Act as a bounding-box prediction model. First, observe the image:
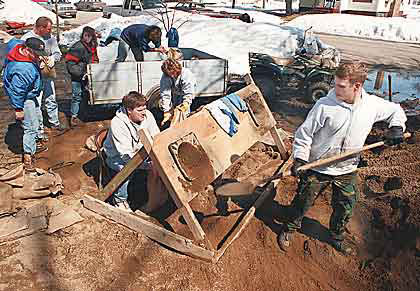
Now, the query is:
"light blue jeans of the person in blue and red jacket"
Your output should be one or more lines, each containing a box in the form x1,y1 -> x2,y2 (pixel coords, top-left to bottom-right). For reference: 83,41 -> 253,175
22,99 -> 40,155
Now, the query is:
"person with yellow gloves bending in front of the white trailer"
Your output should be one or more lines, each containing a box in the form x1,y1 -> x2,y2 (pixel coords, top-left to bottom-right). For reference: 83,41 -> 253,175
159,51 -> 196,126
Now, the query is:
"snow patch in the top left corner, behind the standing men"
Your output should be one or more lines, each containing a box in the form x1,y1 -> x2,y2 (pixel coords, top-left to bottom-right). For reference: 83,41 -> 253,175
0,0 -> 56,24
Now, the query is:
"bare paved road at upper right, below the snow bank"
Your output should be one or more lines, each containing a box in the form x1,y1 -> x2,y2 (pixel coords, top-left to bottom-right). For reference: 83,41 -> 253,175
319,34 -> 420,71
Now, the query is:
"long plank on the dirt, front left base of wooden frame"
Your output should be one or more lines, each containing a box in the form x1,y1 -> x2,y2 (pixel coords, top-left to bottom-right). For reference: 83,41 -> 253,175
82,195 -> 214,261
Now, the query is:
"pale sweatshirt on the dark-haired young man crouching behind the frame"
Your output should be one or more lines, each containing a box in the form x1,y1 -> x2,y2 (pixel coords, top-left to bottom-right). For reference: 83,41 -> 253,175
104,106 -> 160,171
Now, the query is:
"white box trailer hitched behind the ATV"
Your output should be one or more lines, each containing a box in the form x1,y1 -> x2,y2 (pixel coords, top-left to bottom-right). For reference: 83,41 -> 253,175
87,48 -> 233,105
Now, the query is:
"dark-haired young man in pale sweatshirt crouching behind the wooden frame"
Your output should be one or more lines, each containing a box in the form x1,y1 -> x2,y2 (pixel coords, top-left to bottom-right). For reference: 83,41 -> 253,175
104,91 -> 167,212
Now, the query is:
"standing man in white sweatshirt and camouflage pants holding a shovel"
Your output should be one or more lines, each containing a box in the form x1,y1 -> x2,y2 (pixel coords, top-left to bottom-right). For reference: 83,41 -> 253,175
277,62 -> 407,254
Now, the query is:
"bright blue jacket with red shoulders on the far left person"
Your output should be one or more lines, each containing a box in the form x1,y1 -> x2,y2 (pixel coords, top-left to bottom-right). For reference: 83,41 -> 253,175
3,44 -> 42,110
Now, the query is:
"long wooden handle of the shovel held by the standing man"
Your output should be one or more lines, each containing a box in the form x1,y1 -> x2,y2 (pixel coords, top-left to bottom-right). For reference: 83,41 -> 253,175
266,132 -> 411,182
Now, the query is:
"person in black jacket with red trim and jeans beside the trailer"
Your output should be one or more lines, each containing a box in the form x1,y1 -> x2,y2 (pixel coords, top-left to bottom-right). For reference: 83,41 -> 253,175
65,26 -> 99,127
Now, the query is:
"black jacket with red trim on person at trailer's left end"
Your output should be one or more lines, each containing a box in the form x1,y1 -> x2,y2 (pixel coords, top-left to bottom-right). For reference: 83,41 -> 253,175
65,41 -> 99,82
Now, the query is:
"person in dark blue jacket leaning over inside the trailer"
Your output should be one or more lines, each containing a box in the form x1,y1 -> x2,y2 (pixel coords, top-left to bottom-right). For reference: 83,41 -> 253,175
116,24 -> 166,62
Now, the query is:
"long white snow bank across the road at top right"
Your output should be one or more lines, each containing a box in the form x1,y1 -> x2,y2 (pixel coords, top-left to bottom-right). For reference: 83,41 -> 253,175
287,14 -> 420,42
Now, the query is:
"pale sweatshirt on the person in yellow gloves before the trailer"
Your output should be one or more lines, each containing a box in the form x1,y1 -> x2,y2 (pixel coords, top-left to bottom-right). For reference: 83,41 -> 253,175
159,68 -> 196,112
